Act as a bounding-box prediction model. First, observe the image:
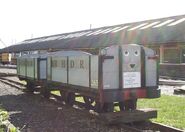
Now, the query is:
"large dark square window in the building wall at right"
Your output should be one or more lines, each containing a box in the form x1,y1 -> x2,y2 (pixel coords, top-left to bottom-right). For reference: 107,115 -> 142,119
163,49 -> 180,63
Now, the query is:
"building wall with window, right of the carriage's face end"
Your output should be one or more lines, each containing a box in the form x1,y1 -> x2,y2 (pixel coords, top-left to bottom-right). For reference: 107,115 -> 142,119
151,43 -> 185,80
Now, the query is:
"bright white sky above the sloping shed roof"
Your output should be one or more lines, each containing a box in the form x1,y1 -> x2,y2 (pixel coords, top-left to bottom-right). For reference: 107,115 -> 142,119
0,0 -> 185,48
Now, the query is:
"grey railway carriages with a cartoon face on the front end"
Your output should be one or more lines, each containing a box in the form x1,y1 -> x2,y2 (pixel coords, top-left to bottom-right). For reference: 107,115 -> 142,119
17,44 -> 160,112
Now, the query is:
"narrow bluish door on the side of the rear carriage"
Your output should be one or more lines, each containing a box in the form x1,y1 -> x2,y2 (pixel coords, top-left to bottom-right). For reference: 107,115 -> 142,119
39,59 -> 47,79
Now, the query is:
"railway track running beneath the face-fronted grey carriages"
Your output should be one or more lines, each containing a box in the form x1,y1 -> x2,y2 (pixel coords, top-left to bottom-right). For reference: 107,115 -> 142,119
0,76 -> 183,132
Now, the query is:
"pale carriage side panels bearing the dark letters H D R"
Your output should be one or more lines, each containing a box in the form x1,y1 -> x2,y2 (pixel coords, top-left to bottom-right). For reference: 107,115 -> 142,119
48,51 -> 91,87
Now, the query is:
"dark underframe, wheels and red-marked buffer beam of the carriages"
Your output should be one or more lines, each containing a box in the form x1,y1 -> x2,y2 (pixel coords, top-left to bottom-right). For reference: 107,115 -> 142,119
22,77 -> 160,113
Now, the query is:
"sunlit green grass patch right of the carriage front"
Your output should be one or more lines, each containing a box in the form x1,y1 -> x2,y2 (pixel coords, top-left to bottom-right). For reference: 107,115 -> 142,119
138,95 -> 185,130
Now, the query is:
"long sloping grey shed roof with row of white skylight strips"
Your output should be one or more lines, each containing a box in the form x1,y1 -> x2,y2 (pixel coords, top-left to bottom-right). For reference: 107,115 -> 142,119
0,15 -> 185,53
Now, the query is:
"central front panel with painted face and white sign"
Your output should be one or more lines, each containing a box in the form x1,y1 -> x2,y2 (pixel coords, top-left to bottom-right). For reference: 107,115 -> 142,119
122,44 -> 141,88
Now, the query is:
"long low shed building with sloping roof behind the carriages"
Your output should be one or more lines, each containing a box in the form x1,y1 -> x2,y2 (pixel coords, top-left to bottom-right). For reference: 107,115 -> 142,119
0,15 -> 185,78
